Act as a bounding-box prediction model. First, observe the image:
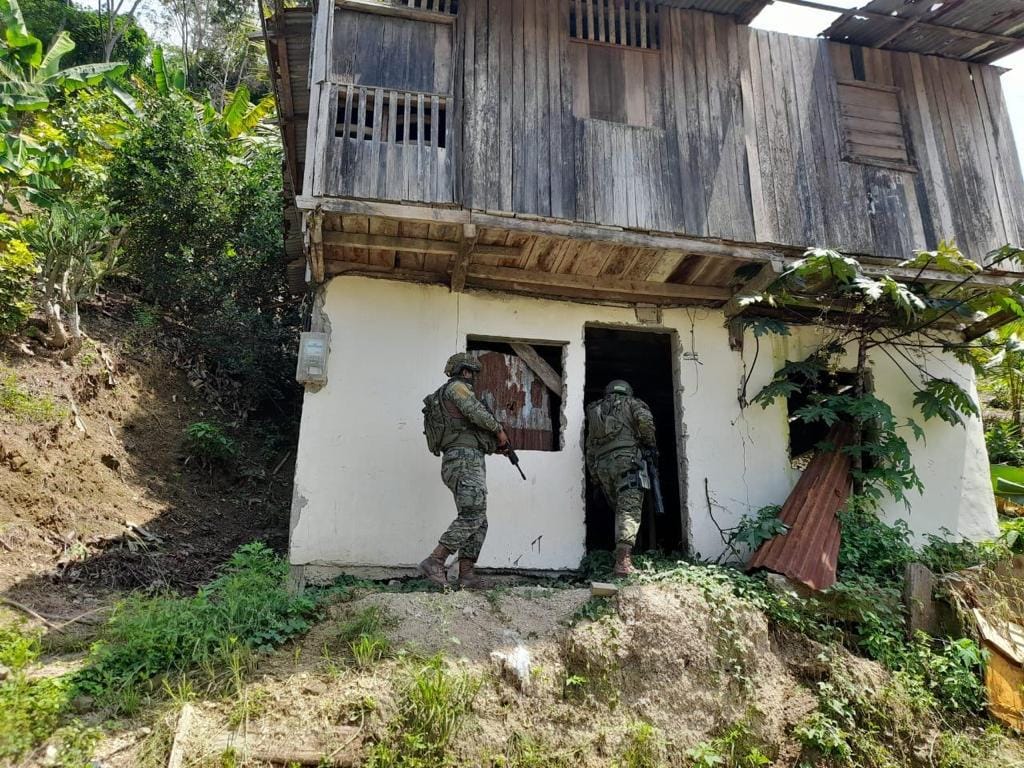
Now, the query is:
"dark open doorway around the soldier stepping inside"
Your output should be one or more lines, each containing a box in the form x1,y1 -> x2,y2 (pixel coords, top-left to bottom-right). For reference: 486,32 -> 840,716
584,328 -> 685,552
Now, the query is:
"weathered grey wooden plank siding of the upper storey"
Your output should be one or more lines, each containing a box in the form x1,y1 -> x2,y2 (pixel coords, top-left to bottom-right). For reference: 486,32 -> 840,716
304,0 -> 1024,276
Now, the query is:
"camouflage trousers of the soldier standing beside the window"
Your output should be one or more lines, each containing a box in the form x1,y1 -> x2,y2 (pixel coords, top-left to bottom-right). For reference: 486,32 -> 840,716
439,447 -> 487,561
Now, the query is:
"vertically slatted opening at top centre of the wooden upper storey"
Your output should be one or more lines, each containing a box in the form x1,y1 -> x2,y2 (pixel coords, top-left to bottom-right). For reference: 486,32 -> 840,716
568,0 -> 662,49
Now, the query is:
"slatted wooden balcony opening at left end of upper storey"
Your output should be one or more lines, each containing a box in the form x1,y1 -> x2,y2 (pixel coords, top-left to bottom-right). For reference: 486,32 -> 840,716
335,85 -> 447,148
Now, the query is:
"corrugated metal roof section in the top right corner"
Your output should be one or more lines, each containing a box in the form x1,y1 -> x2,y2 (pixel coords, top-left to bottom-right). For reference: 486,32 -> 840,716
822,0 -> 1024,62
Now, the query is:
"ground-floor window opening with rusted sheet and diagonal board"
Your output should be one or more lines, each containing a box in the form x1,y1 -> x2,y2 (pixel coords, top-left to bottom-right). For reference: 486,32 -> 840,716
466,337 -> 565,451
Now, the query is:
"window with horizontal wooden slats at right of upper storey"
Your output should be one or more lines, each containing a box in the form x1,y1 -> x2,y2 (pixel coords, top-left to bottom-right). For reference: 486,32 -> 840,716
837,80 -> 915,171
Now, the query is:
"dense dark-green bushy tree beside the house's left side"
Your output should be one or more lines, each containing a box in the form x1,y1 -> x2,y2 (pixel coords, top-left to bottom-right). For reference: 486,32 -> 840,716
108,89 -> 298,412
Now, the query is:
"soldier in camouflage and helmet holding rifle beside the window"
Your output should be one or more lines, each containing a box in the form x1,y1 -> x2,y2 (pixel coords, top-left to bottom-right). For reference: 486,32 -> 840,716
420,353 -> 509,589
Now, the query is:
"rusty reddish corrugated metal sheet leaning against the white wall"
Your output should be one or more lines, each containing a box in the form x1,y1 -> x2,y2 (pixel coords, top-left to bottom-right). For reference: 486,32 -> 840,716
748,425 -> 854,590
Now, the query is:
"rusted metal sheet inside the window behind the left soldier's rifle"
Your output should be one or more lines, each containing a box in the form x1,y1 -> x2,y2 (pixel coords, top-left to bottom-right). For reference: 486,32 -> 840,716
473,352 -> 553,451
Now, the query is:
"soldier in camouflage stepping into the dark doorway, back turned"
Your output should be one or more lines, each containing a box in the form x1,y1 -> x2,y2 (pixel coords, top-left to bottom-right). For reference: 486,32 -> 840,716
587,380 -> 657,575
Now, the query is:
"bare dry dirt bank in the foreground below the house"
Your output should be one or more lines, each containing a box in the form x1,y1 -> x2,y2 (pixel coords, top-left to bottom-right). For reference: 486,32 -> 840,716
128,584 -> 816,768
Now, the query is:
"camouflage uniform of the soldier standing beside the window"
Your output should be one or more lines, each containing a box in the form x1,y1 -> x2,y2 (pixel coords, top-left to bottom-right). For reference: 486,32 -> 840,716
439,378 -> 502,561
